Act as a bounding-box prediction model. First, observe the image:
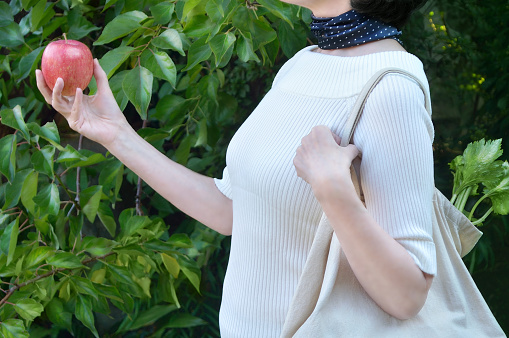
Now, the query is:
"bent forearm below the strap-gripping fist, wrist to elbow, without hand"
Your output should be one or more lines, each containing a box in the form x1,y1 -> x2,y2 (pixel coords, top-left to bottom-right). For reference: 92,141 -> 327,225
319,182 -> 432,319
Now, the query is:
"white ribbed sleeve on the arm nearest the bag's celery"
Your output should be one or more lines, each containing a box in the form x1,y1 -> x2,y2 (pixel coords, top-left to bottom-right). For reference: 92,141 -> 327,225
354,75 -> 436,275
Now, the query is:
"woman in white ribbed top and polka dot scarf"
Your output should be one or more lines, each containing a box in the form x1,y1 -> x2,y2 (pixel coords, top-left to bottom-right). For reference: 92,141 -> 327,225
37,0 -> 436,337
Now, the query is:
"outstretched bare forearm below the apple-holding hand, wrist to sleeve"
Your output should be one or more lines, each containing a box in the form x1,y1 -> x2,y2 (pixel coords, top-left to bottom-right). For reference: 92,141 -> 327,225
105,126 -> 233,235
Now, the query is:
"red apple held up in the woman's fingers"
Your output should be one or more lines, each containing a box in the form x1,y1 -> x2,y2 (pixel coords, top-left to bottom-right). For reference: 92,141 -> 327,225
41,40 -> 94,96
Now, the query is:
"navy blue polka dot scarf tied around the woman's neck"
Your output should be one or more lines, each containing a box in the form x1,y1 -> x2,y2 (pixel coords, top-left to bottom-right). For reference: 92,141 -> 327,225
311,10 -> 401,49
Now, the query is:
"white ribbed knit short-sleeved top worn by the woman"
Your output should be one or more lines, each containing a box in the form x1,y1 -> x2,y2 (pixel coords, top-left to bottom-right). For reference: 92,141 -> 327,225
215,46 -> 436,338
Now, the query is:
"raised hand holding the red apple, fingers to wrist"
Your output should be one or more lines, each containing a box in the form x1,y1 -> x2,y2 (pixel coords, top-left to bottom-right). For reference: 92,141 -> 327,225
36,59 -> 130,148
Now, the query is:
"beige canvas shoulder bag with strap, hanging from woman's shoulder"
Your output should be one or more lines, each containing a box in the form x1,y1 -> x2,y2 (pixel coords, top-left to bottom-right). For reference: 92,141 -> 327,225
281,68 -> 506,338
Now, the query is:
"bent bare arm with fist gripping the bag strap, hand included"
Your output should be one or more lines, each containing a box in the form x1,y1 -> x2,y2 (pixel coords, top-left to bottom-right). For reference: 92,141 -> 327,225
294,126 -> 433,319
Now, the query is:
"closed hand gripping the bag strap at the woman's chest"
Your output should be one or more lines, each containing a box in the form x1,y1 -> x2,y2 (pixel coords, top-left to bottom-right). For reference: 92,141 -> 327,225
293,126 -> 359,199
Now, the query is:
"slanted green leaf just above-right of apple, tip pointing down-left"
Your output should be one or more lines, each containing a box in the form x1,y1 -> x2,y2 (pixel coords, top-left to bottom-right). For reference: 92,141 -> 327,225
94,11 -> 147,46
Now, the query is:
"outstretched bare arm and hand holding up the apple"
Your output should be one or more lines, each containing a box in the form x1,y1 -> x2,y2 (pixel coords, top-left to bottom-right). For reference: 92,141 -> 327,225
36,60 -> 233,235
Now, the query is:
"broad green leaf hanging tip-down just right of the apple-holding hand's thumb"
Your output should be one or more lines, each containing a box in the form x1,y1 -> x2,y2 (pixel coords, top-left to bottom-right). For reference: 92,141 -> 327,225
122,66 -> 153,120
